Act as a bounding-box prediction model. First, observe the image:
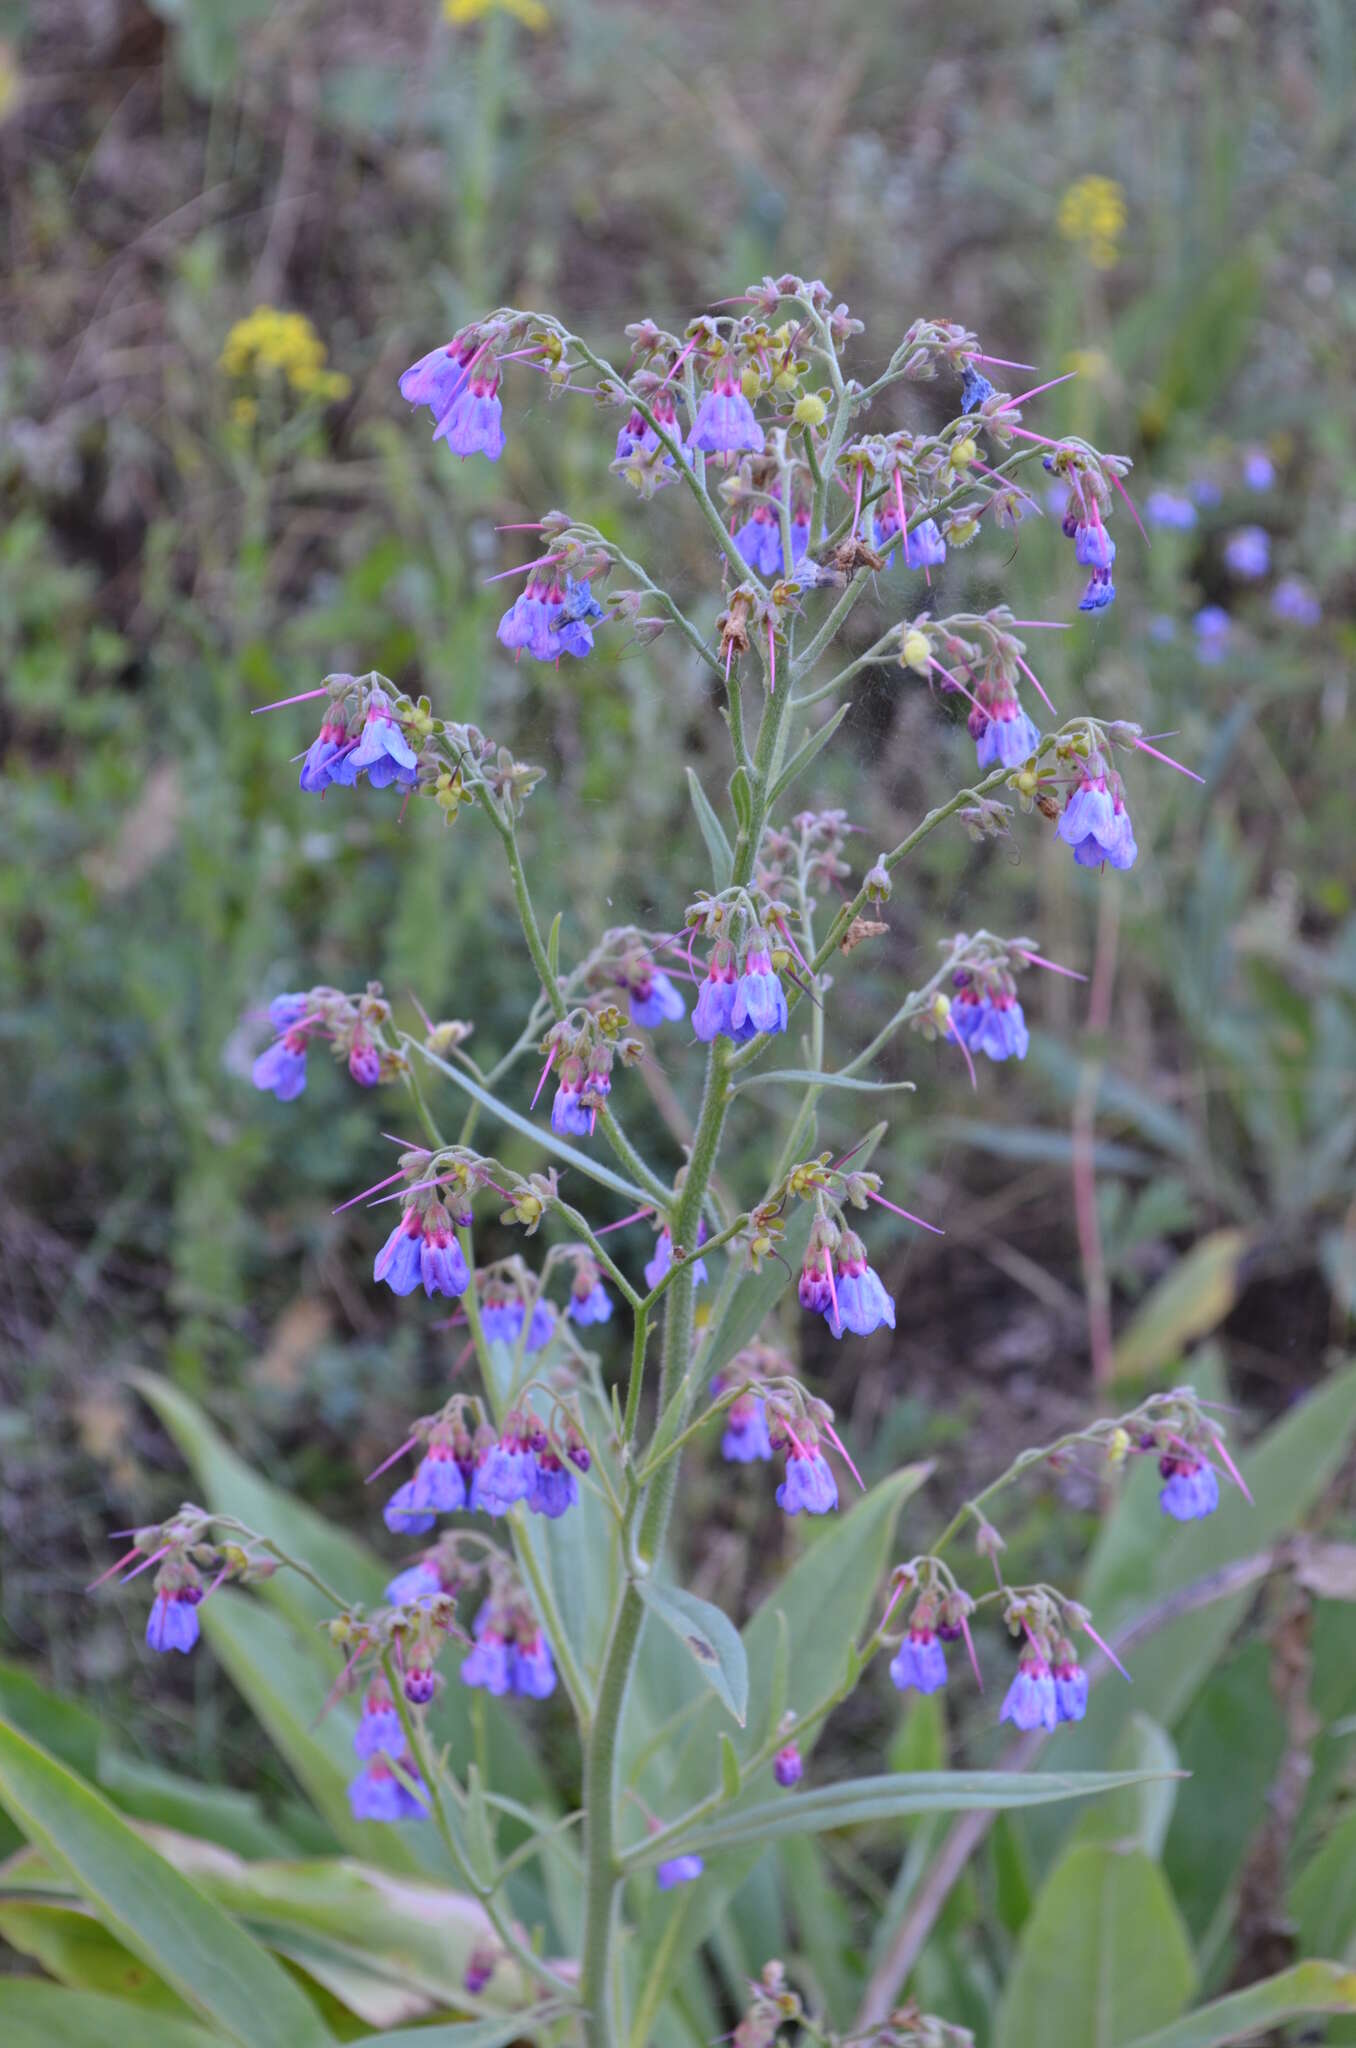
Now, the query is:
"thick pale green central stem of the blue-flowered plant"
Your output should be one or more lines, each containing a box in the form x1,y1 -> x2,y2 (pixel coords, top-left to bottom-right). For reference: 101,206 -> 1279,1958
580,647 -> 791,2048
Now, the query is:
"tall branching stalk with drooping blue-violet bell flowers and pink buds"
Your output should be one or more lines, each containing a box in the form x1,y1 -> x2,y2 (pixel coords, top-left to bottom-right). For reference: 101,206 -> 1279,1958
93,276 -> 1241,2048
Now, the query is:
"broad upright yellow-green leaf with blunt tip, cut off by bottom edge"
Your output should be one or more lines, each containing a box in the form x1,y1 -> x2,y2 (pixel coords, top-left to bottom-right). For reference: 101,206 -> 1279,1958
995,1843 -> 1196,2048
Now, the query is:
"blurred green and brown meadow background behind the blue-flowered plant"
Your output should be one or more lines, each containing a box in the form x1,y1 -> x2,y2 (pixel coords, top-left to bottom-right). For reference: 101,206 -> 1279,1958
0,0 -> 1356,2044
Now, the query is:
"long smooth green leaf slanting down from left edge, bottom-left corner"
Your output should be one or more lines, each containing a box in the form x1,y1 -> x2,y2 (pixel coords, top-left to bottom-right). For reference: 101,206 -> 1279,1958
0,1722 -> 330,2048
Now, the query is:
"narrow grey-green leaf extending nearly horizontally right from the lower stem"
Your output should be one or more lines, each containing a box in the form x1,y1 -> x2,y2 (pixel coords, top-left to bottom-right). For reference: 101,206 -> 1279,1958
627,1772 -> 1171,1870
